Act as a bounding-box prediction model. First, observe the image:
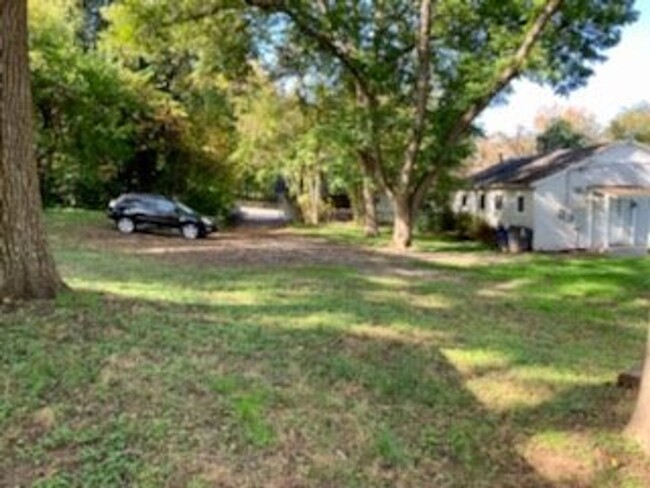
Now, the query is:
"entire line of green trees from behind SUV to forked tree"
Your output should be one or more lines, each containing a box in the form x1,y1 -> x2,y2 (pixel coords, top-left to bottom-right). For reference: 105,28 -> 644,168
4,0 -> 637,290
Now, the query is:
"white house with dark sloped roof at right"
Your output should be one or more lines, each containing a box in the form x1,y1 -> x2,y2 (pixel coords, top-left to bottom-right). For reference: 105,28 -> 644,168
452,142 -> 650,251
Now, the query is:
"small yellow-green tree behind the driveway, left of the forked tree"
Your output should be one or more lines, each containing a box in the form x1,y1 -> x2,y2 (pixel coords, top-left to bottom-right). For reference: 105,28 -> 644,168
233,66 -> 355,224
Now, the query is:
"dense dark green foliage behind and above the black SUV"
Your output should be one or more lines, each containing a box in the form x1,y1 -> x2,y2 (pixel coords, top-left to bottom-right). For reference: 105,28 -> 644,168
30,0 -> 240,215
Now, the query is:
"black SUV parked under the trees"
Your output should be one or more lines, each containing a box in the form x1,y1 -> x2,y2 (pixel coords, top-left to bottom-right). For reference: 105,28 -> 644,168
106,193 -> 216,239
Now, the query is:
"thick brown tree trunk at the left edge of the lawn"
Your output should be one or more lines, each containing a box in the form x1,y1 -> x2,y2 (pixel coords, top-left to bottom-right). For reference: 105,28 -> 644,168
0,0 -> 62,300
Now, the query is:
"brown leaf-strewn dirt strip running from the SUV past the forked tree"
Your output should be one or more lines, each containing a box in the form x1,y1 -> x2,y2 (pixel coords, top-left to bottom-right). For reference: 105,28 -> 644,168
67,223 -> 522,277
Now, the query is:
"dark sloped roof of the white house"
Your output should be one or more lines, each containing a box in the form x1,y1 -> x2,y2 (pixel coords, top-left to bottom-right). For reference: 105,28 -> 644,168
470,144 -> 605,187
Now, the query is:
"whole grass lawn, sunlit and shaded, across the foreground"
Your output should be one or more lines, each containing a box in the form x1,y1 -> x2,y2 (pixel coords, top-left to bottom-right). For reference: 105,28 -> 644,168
0,212 -> 650,487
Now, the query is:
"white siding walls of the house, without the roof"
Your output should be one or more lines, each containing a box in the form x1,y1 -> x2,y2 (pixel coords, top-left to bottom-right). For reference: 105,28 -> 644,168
452,143 -> 650,251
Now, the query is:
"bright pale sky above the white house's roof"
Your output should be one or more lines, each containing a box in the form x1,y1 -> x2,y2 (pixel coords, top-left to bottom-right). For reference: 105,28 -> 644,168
479,0 -> 650,134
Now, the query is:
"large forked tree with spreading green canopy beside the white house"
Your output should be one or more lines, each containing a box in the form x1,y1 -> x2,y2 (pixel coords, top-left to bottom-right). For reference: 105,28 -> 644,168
242,0 -> 636,248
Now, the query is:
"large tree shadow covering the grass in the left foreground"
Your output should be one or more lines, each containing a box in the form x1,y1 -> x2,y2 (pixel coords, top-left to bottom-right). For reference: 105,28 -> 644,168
0,291 -> 549,487
